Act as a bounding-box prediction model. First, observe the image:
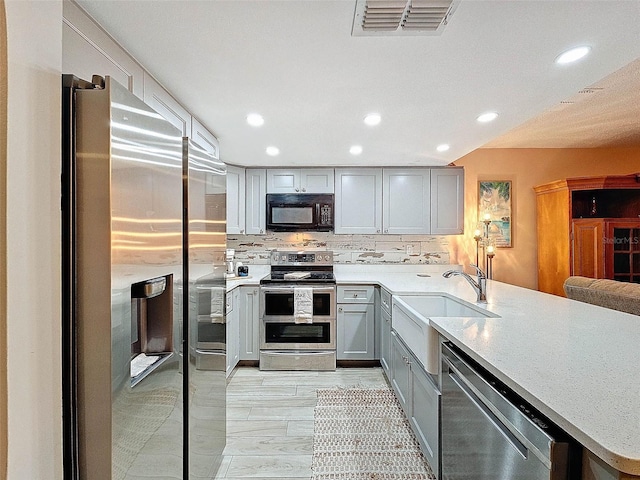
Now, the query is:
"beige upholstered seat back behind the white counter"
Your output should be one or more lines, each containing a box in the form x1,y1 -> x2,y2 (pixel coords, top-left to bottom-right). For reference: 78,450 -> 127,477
564,277 -> 640,315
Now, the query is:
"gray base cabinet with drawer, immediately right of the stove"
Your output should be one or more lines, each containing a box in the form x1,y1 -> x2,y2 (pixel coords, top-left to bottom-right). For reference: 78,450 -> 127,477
336,285 -> 375,360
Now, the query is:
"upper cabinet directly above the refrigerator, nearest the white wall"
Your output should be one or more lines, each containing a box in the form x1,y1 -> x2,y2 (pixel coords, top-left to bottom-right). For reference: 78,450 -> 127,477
62,2 -> 144,99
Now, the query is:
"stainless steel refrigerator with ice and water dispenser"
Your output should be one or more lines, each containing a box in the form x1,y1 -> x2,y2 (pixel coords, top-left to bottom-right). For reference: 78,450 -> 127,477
62,75 -> 226,480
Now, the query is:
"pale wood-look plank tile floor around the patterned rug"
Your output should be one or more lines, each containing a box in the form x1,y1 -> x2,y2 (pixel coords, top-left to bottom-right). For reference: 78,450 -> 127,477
215,367 -> 386,480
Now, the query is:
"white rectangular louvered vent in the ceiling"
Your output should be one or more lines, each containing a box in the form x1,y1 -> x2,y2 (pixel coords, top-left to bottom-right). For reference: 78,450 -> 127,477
351,0 -> 458,36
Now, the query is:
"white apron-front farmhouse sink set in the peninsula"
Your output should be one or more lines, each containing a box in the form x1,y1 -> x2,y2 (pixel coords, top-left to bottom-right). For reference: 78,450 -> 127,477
391,295 -> 497,375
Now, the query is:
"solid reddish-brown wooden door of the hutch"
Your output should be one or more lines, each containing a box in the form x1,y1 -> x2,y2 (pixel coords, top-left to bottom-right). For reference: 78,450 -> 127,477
571,219 -> 605,278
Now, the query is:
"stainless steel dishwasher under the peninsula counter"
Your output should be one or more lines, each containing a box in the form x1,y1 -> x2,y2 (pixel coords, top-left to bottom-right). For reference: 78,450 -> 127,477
440,343 -> 574,480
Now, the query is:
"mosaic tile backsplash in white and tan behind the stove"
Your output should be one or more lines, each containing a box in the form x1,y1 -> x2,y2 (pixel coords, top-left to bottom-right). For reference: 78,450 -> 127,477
227,232 -> 450,265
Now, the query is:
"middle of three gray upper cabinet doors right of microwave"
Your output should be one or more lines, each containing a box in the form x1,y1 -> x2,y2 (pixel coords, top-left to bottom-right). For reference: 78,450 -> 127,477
382,168 -> 431,234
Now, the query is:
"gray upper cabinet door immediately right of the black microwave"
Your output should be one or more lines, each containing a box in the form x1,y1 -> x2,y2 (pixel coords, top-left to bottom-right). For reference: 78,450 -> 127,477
334,168 -> 382,234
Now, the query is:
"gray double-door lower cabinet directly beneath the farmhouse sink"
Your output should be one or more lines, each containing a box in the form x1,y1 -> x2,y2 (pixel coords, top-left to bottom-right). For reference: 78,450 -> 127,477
389,330 -> 441,478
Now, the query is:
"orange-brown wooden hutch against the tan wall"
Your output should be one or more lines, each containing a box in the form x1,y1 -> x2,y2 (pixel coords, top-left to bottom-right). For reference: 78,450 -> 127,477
534,173 -> 640,296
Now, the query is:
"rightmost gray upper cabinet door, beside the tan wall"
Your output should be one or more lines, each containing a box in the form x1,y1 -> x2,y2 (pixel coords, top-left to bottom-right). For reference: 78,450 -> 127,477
431,167 -> 464,235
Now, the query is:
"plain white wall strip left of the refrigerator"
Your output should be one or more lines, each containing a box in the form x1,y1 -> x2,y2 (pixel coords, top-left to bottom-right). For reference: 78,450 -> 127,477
5,0 -> 62,480
